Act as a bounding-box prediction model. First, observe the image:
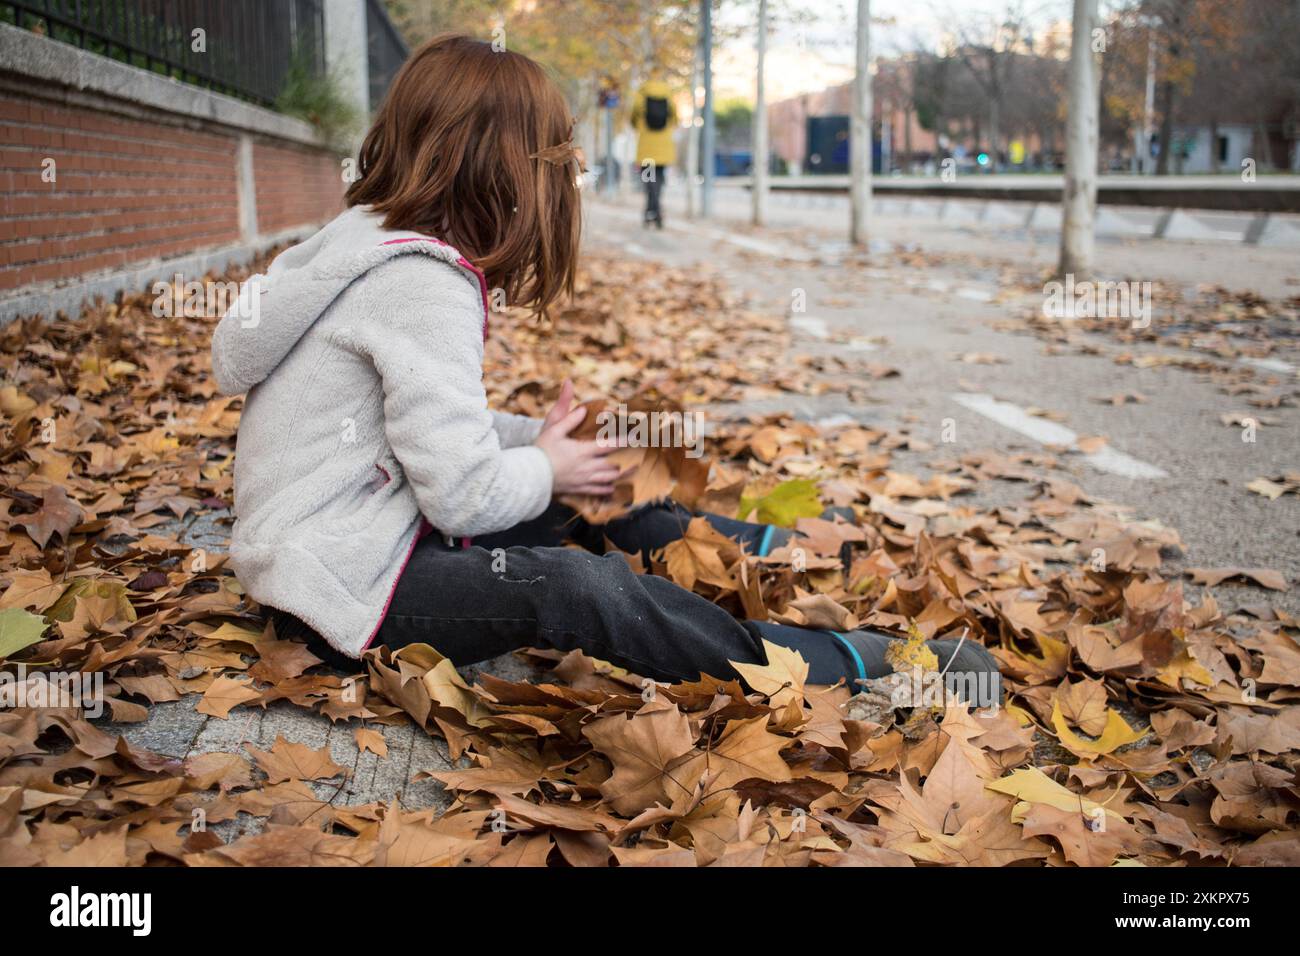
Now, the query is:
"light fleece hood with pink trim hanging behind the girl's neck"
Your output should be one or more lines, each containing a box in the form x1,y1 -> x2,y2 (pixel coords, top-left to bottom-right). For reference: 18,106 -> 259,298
212,207 -> 488,395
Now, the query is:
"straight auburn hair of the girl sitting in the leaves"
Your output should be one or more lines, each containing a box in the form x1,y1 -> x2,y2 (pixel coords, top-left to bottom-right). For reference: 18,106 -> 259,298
347,34 -> 581,312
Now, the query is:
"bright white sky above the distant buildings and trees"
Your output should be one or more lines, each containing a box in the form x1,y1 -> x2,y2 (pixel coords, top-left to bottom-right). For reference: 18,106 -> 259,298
714,0 -> 1071,101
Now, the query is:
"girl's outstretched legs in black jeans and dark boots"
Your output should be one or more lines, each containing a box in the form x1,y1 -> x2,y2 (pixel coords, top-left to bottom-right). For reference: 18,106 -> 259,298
345,505 -> 996,689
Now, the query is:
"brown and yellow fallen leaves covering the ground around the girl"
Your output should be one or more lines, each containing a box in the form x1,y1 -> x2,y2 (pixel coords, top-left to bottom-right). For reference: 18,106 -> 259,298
0,252 -> 1300,866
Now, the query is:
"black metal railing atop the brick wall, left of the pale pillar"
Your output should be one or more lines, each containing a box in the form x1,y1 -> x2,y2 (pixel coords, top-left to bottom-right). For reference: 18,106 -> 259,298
0,0 -> 327,107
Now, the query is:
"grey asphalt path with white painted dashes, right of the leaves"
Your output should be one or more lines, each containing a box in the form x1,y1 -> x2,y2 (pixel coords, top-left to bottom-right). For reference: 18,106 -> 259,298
586,190 -> 1300,613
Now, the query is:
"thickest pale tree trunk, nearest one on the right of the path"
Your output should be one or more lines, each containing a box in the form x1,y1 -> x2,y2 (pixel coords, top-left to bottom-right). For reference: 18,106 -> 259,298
1058,0 -> 1101,280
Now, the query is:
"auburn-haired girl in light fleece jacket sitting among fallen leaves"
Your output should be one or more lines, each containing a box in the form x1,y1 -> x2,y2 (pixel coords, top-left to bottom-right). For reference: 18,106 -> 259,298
212,35 -> 997,704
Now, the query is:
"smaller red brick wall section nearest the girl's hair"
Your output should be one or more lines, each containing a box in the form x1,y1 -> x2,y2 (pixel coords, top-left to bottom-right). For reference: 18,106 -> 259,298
252,143 -> 343,233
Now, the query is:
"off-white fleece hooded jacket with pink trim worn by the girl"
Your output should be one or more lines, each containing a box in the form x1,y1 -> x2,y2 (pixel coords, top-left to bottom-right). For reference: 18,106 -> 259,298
212,208 -> 551,657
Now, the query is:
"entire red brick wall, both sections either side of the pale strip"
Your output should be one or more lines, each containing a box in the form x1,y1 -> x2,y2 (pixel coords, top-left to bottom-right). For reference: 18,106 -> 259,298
0,90 -> 345,300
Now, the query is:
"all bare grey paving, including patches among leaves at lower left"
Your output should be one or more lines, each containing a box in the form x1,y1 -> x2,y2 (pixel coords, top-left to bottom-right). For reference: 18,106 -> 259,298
113,198 -> 1300,822
